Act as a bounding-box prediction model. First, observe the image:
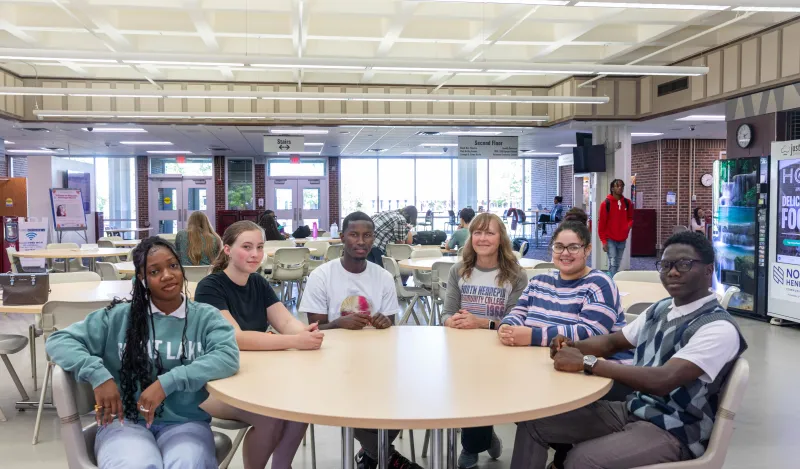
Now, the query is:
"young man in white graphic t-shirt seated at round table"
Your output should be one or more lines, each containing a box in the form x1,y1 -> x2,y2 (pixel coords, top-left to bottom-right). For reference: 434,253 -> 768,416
299,212 -> 421,469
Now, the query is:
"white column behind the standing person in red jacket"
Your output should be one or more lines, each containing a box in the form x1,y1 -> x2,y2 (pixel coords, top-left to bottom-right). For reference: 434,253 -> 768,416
589,123 -> 631,270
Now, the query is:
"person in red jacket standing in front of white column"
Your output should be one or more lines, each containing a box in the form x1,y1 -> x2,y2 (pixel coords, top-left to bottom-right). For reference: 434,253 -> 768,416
597,179 -> 633,277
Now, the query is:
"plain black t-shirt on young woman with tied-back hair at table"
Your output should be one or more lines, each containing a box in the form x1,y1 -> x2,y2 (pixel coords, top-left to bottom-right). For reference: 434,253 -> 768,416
194,272 -> 280,332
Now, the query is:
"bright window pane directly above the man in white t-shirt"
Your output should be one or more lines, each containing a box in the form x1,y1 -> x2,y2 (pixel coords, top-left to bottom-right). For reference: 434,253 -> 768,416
339,158 -> 378,218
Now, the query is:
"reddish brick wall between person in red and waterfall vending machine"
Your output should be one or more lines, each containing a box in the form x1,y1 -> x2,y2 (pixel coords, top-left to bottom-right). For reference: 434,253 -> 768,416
631,140 -> 726,244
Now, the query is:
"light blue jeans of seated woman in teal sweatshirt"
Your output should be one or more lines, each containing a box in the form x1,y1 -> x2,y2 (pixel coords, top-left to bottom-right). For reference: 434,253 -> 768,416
94,420 -> 217,469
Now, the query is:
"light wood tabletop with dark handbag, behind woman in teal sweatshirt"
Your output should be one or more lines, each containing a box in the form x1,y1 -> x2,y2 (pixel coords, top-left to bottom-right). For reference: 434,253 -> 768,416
0,280 -> 197,314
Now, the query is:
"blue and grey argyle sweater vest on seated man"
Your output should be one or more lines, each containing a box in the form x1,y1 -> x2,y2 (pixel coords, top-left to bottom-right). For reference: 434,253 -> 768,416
628,298 -> 747,458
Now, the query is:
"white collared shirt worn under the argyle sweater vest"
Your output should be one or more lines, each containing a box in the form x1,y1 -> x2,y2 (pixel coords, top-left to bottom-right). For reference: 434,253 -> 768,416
622,293 -> 739,383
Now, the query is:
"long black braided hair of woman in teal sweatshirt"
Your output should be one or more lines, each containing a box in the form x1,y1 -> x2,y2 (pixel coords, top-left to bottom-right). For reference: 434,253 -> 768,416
106,236 -> 189,423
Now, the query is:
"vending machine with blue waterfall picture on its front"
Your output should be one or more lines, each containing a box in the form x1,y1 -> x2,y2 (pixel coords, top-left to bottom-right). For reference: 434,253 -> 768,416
711,157 -> 770,321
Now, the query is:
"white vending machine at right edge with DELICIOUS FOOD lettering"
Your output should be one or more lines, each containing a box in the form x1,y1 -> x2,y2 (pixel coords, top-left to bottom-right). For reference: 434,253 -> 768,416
768,140 -> 800,322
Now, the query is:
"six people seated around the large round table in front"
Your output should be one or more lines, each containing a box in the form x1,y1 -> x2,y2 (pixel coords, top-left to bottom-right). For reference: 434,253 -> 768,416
42,203 -> 747,469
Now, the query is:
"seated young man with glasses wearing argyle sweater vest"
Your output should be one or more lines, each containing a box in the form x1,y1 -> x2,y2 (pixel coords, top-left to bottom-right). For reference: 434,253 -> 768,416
511,232 -> 747,469
